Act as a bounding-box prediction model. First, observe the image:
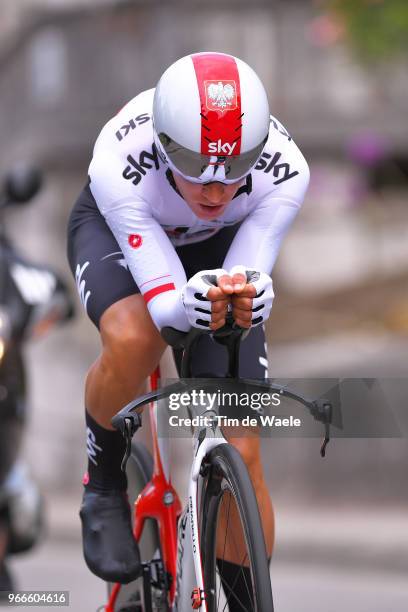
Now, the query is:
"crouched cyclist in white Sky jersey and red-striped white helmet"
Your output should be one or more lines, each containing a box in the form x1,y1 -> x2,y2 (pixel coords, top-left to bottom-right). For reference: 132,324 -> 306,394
68,53 -> 309,597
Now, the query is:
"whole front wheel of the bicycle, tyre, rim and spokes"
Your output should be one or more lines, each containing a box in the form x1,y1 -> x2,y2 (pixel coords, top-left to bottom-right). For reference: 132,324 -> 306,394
199,444 -> 273,612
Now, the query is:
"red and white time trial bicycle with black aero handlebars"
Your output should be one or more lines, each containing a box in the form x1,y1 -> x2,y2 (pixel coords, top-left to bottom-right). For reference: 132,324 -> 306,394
102,323 -> 332,612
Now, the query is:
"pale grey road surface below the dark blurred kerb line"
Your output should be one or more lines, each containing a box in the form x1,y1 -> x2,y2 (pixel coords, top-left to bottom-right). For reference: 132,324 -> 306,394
6,541 -> 408,612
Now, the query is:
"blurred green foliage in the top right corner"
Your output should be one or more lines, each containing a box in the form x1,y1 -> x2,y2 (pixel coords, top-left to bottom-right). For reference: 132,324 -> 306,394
321,0 -> 408,63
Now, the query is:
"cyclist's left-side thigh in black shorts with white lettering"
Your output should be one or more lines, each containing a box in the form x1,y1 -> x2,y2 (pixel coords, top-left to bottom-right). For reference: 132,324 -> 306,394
68,186 -> 140,328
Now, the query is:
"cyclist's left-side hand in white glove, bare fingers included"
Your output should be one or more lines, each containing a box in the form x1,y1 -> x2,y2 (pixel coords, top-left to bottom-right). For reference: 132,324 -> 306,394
181,268 -> 233,331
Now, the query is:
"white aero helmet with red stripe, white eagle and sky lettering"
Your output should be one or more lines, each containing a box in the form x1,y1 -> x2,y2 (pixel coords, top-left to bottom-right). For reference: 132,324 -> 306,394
153,53 -> 270,183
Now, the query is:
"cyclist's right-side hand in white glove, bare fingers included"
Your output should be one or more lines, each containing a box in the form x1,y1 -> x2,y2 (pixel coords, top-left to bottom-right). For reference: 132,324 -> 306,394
230,266 -> 274,328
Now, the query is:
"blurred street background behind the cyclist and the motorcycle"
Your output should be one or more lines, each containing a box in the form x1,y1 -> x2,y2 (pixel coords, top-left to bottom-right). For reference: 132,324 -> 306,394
0,0 -> 408,612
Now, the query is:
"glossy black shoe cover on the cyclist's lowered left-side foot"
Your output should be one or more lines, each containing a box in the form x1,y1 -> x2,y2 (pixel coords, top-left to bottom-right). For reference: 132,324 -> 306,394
79,485 -> 142,584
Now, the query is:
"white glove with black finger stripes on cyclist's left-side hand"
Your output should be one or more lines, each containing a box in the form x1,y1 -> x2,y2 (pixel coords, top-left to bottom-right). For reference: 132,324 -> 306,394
181,268 -> 227,329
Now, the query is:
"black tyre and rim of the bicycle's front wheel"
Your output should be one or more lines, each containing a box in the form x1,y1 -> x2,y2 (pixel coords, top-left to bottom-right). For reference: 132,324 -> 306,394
198,444 -> 273,612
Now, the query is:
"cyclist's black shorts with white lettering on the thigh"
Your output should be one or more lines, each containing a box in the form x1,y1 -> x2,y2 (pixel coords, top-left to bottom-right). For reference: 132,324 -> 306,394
68,185 -> 266,378
